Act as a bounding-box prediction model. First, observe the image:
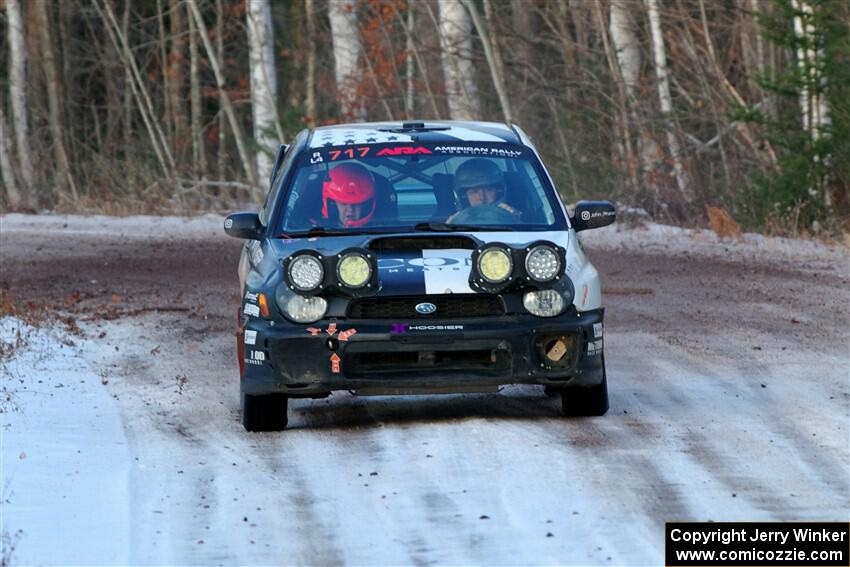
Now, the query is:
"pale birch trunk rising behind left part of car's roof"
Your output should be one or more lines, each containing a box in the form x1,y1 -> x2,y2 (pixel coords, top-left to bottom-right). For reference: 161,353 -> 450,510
328,0 -> 366,122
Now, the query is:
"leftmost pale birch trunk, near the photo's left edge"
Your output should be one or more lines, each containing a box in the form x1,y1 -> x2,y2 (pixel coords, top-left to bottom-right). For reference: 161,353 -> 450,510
6,0 -> 38,209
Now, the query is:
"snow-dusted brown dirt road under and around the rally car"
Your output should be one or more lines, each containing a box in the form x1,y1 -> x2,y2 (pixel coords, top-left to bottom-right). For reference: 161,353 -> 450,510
0,215 -> 850,565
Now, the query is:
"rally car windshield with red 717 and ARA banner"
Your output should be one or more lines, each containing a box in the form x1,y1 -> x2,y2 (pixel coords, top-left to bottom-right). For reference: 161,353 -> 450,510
277,143 -> 565,235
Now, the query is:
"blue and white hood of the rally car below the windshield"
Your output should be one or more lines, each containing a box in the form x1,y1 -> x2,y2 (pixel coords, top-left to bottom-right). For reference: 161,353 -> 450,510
270,230 -> 569,295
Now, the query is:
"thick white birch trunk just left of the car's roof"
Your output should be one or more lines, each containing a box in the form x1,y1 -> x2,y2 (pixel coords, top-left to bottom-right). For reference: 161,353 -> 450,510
246,0 -> 283,183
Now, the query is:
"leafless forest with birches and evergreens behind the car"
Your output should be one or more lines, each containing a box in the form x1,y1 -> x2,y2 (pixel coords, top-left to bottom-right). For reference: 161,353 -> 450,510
0,0 -> 850,238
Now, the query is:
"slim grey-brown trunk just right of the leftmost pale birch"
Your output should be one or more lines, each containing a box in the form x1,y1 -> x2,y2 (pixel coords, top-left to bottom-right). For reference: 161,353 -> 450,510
33,2 -> 79,201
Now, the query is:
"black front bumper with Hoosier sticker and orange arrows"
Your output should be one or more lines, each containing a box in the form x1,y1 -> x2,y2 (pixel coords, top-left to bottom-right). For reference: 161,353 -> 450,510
239,309 -> 604,397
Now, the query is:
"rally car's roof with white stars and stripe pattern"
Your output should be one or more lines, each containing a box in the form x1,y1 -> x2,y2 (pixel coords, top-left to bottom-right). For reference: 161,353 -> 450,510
309,120 -> 523,148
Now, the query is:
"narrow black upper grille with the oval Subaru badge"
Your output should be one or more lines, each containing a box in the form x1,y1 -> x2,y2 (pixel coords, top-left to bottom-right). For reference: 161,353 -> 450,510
348,293 -> 505,319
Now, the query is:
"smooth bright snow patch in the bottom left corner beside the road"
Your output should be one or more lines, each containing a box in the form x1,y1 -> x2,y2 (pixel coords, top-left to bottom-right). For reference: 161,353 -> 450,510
0,317 -> 130,565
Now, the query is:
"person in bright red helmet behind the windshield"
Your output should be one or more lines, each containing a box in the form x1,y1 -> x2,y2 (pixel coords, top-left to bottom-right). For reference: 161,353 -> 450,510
322,163 -> 376,228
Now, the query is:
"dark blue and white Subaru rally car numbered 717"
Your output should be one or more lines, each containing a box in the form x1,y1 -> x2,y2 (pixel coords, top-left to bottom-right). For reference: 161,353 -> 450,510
224,121 -> 615,431
